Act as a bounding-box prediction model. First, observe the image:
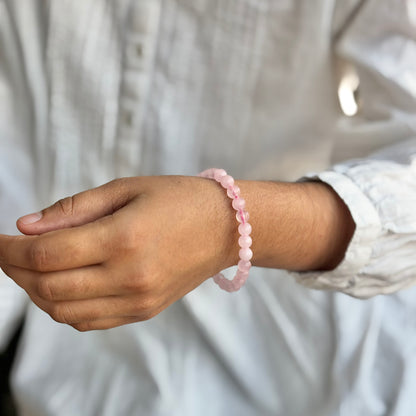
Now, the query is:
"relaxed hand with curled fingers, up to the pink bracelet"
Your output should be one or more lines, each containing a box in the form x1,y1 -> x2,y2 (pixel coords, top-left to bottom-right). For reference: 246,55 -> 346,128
0,176 -> 238,331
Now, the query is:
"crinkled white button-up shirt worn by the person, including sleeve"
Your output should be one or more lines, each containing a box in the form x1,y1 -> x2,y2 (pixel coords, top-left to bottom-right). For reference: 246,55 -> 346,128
0,0 -> 416,416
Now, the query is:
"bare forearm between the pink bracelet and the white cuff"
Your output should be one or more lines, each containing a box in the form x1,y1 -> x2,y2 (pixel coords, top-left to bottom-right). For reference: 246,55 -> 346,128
233,181 -> 355,271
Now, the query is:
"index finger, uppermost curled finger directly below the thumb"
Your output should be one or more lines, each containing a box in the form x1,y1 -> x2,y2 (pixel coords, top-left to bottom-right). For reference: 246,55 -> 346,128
0,216 -> 113,272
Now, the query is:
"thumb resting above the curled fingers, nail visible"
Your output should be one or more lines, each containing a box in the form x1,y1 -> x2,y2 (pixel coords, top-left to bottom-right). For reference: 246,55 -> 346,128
16,180 -> 131,235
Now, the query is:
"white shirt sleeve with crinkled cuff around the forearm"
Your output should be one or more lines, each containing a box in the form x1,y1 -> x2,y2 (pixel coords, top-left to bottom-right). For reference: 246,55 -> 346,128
293,0 -> 416,298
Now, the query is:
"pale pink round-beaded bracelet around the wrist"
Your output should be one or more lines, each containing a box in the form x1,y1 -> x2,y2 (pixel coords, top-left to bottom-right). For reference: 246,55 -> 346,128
198,168 -> 253,292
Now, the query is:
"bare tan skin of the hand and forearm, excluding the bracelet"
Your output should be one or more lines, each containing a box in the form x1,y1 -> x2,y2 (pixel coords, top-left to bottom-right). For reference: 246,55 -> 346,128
0,176 -> 355,331
